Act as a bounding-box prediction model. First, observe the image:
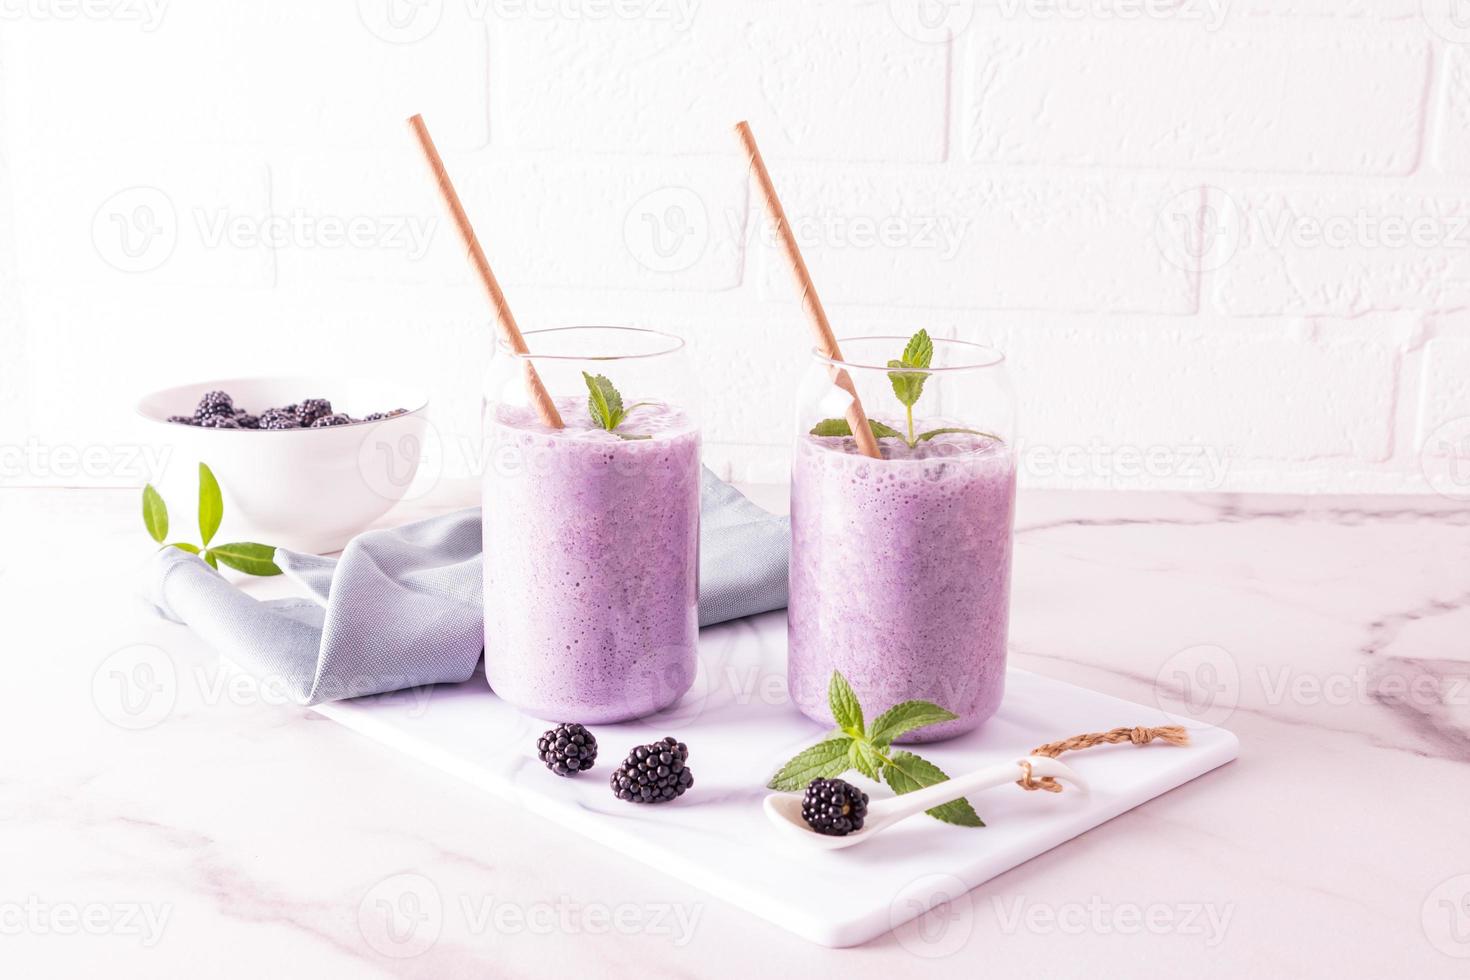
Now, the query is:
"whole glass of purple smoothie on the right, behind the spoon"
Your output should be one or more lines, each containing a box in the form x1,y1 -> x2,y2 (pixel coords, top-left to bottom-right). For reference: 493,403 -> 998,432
786,337 -> 1016,742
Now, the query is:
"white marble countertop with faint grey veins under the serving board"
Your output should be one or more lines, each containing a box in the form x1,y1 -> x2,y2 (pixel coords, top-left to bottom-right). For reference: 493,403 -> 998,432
0,486 -> 1470,979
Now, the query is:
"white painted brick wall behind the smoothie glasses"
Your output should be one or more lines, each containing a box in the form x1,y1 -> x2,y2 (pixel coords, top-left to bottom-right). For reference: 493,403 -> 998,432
0,0 -> 1470,492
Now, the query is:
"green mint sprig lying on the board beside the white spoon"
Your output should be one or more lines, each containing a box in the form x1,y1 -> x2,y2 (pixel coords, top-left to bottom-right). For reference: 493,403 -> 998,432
766,670 -> 985,827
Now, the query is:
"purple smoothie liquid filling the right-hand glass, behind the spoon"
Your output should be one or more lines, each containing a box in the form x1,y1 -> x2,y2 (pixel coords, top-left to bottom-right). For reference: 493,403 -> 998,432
788,423 -> 1016,742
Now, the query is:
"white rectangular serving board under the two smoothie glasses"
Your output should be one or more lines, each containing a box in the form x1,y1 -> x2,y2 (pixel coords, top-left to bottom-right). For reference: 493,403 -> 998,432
318,613 -> 1239,946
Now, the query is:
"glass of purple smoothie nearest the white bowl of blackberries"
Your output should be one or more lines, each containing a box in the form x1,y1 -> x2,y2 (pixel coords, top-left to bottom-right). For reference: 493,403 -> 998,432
484,326 -> 700,723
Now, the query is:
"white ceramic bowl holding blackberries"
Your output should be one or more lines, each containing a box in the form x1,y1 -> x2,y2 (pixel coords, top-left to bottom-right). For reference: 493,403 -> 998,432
137,378 -> 428,554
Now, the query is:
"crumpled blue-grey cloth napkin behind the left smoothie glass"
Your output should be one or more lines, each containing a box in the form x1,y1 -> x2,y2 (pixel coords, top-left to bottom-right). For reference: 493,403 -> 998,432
144,470 -> 789,705
